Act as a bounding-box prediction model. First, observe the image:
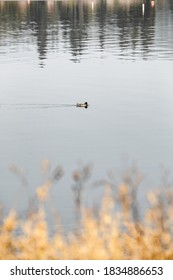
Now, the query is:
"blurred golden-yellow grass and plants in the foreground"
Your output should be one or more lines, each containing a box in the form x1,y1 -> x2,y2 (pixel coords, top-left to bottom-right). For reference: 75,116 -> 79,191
0,162 -> 173,260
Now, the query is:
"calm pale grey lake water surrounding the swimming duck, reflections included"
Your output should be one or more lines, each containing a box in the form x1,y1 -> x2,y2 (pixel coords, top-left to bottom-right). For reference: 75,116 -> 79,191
0,0 -> 173,229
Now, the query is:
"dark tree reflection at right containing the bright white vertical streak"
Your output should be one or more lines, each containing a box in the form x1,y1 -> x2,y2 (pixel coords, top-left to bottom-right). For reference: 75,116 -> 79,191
117,1 -> 155,58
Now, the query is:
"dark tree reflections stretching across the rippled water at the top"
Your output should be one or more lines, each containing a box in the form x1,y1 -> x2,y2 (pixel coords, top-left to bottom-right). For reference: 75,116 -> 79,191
0,0 -> 173,66
